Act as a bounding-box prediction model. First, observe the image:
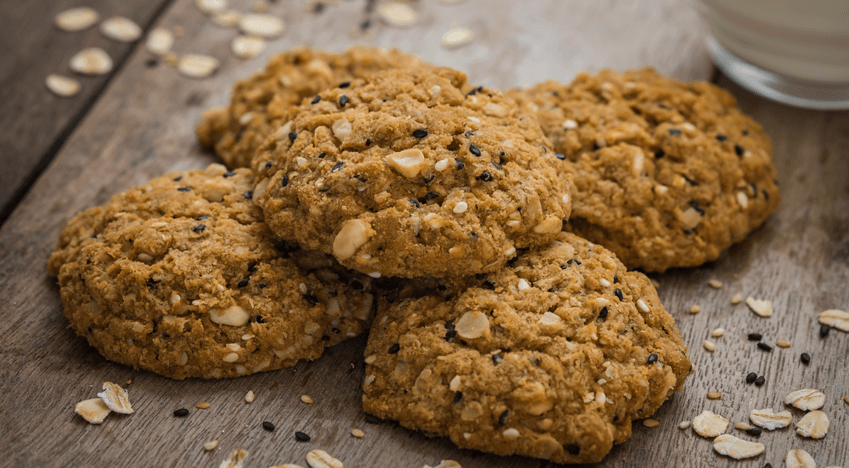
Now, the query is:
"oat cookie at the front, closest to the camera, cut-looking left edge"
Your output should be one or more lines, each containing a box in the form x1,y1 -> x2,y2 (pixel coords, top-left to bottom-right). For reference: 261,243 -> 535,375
363,232 -> 690,463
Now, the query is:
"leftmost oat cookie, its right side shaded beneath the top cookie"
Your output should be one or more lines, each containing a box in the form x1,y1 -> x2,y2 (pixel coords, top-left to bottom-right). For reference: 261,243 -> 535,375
48,164 -> 373,379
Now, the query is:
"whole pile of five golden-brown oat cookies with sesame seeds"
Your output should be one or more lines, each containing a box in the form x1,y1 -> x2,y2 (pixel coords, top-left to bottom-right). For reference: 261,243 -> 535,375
44,47 -> 779,463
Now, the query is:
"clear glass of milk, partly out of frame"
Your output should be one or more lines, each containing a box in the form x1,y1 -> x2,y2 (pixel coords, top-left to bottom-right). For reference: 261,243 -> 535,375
697,0 -> 849,109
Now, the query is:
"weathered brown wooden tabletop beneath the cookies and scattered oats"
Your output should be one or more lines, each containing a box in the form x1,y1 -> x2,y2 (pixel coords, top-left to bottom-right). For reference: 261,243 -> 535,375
0,0 -> 849,468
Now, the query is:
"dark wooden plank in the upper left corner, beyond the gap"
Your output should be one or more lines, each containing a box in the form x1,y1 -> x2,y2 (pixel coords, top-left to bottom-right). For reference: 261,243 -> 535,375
0,0 -> 169,223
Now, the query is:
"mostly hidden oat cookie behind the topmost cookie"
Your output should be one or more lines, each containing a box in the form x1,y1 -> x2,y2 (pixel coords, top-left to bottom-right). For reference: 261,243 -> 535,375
197,46 -> 422,168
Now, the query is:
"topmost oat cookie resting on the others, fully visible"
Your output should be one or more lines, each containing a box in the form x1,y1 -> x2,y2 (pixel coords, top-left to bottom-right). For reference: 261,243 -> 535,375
253,67 -> 571,278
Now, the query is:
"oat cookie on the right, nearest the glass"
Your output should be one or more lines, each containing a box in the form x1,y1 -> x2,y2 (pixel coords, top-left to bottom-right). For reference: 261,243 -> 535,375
511,69 -> 780,272
